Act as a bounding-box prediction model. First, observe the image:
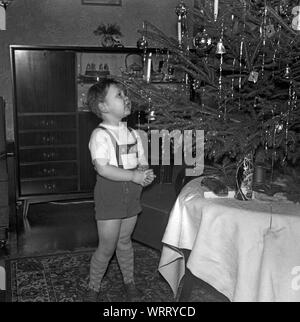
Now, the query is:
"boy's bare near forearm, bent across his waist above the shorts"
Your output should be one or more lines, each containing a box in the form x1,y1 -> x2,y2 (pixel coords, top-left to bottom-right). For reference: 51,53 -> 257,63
94,159 -> 152,185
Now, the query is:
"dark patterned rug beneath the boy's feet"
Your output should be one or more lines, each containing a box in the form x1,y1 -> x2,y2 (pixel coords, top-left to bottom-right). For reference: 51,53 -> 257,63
6,243 -> 229,302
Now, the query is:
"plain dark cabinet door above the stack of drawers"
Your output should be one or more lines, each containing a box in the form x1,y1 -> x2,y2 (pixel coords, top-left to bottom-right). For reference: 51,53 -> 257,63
13,50 -> 76,113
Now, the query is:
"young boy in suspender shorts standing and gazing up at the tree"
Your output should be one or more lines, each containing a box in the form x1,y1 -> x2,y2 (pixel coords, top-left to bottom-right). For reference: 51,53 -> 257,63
85,79 -> 155,302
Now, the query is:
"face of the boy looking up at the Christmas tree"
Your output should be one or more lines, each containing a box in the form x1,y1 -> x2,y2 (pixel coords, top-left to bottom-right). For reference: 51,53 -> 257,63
103,84 -> 131,120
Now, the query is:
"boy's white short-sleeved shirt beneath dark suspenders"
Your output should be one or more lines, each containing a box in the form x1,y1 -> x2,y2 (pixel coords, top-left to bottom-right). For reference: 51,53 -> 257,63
89,122 -> 148,169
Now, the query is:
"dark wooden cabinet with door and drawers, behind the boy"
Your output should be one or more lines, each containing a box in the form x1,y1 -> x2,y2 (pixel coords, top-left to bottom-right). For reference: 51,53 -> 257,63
11,46 -> 98,217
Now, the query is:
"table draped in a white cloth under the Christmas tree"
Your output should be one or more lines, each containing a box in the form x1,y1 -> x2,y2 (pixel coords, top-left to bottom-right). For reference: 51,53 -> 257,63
158,177 -> 300,302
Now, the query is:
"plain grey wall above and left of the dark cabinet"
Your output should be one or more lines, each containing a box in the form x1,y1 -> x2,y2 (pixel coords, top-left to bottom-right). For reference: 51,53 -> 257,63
0,0 -> 192,139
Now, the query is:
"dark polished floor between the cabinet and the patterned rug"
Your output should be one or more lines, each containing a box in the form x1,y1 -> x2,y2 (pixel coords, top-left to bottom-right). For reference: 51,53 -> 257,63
0,202 -> 103,302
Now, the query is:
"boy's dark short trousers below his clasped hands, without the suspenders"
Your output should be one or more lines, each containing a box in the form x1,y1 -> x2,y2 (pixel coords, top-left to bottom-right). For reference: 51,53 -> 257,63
94,176 -> 143,220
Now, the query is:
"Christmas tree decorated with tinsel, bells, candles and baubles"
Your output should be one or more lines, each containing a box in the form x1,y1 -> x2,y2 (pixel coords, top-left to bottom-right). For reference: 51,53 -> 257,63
120,0 -> 300,186
